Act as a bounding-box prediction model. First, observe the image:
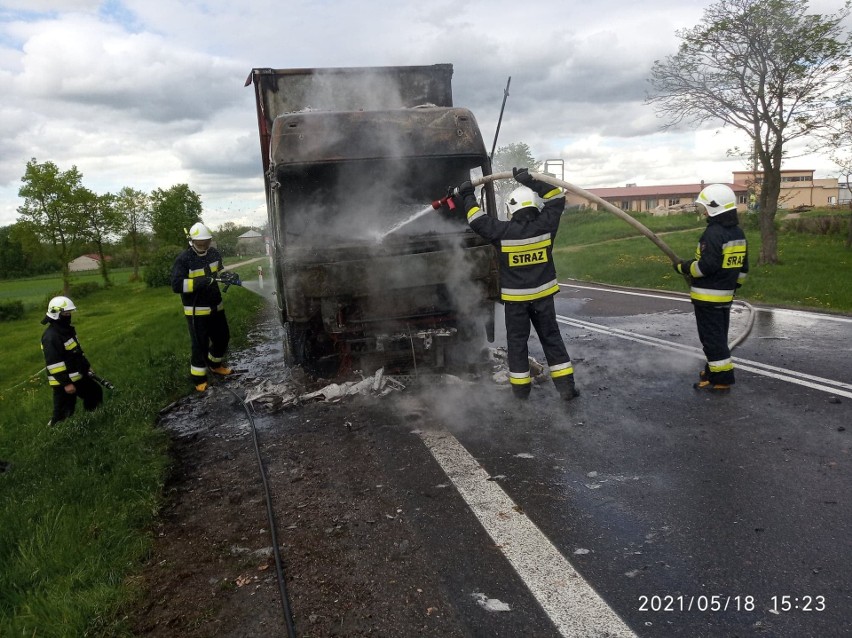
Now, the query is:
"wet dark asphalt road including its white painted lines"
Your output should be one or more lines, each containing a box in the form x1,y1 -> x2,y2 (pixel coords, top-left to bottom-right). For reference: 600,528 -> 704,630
408,284 -> 852,638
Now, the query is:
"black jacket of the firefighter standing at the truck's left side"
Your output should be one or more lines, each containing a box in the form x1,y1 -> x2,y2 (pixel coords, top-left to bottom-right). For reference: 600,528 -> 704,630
172,248 -> 224,317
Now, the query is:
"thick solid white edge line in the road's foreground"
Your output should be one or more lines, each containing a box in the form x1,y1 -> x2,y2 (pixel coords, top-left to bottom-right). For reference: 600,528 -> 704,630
418,430 -> 636,638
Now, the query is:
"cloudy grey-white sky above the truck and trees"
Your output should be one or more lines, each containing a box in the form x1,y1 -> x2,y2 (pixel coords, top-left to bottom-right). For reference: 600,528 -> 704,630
0,0 -> 842,228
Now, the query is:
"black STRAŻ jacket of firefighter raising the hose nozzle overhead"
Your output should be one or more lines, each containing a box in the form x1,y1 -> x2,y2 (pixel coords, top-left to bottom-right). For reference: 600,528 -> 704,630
464,188 -> 565,302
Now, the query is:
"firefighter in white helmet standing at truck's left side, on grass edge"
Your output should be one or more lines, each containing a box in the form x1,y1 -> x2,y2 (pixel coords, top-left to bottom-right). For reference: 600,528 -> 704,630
172,222 -> 233,392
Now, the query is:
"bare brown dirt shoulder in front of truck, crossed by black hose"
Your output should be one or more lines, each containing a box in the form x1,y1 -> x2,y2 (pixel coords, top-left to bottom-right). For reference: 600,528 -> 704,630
133,316 -> 472,638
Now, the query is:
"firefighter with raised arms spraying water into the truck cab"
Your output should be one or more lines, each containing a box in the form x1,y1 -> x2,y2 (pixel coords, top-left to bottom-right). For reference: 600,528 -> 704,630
458,168 -> 580,401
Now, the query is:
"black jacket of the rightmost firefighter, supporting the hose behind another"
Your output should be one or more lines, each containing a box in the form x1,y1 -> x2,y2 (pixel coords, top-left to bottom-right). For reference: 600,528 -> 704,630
678,210 -> 748,304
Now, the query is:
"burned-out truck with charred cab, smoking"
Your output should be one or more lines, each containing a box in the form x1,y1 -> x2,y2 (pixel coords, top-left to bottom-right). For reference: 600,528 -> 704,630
246,64 -> 498,376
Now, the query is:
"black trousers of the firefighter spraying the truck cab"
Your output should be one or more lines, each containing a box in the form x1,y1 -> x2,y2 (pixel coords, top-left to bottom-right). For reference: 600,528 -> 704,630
504,295 -> 574,398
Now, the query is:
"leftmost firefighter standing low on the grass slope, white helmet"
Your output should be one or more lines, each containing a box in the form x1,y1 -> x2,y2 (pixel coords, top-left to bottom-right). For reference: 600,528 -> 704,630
41,296 -> 104,426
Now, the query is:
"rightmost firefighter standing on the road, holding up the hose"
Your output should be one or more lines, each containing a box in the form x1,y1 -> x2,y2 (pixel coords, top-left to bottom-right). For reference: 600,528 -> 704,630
674,184 -> 748,393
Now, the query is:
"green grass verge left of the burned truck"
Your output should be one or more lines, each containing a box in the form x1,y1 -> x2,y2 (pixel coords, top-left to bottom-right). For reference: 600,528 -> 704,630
0,282 -> 263,636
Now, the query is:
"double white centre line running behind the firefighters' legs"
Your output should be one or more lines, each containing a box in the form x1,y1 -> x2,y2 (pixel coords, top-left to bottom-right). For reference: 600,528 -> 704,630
556,315 -> 852,399
